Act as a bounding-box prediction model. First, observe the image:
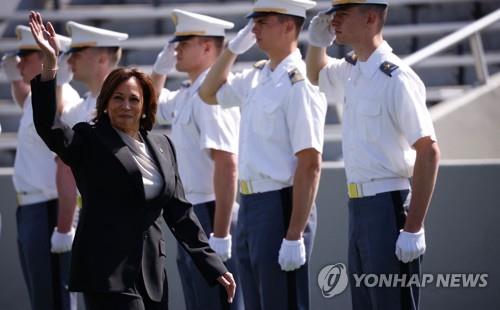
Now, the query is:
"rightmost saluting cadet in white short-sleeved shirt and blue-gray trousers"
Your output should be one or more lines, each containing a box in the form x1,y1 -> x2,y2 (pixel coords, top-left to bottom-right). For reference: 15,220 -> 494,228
307,0 -> 439,310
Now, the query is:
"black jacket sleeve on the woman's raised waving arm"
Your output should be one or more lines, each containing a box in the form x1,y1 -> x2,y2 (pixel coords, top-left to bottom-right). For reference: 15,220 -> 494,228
31,75 -> 83,166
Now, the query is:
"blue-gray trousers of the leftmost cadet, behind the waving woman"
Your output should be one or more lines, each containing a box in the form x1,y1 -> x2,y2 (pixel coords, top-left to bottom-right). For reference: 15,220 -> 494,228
16,200 -> 76,310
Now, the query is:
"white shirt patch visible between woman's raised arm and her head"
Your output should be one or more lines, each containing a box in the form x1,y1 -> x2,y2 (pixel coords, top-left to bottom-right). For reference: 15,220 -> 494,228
61,92 -> 97,128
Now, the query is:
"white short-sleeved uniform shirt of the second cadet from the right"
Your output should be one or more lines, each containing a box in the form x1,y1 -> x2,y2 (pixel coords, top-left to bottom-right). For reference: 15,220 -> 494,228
217,49 -> 327,188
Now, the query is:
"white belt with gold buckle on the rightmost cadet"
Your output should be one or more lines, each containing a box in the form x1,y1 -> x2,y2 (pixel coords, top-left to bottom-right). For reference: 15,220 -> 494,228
347,178 -> 410,198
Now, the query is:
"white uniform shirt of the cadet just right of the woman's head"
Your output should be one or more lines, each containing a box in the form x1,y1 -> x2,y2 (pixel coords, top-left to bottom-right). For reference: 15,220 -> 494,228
158,70 -> 240,204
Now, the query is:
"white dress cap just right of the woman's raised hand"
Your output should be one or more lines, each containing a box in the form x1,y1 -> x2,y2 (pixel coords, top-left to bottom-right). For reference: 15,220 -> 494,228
66,21 -> 128,51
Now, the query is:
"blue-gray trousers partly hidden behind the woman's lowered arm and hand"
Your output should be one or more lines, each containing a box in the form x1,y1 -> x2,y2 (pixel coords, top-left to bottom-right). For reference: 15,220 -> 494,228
177,201 -> 244,310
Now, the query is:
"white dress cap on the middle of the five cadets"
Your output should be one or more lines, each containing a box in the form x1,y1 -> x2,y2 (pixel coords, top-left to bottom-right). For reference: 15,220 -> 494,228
170,9 -> 234,42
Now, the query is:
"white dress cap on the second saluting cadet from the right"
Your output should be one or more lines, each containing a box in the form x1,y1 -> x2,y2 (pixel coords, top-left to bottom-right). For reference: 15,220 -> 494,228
247,0 -> 316,18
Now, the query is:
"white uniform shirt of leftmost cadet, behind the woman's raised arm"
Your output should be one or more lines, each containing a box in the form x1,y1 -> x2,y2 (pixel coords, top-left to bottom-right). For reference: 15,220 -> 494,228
13,84 -> 80,201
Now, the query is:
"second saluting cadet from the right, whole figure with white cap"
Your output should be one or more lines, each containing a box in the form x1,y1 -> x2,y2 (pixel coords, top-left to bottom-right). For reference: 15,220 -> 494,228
199,0 -> 326,310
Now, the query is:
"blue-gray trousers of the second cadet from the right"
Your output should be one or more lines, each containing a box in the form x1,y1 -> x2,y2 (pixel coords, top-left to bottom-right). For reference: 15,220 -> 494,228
236,187 -> 316,310
